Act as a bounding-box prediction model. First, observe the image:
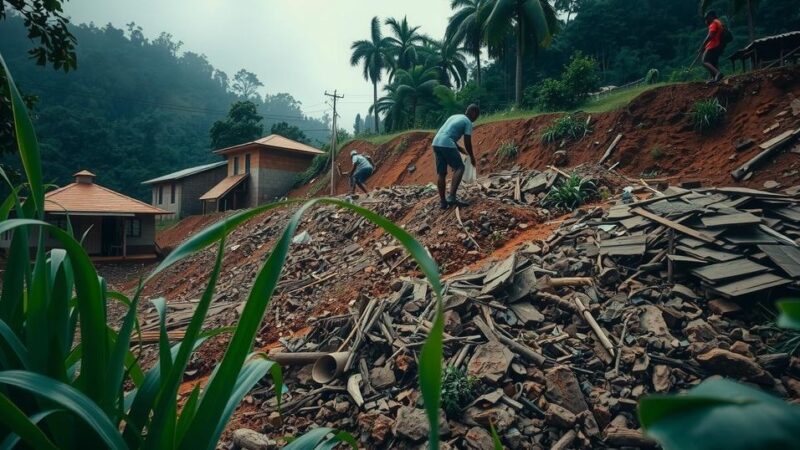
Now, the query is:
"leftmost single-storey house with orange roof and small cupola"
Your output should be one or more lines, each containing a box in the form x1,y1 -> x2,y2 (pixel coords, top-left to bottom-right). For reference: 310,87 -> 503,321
0,170 -> 169,258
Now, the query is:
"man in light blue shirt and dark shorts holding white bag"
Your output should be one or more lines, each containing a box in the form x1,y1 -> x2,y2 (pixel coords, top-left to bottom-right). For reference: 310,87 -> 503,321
433,104 -> 481,209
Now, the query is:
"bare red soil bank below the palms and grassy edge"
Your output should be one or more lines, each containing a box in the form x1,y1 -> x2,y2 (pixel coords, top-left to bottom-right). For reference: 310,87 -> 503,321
292,68 -> 800,197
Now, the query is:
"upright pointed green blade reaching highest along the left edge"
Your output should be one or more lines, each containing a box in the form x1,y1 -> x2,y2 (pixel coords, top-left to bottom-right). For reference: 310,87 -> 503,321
0,52 -> 44,219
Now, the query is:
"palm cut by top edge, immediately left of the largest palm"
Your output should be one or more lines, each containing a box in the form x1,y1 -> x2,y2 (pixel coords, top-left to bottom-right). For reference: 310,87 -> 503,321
445,0 -> 491,86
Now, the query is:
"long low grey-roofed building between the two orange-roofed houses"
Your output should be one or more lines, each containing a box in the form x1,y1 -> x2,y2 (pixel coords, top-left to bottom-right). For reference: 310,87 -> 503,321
142,161 -> 228,219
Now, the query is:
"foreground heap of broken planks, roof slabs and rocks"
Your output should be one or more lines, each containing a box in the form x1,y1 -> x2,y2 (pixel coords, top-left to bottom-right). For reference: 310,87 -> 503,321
233,183 -> 800,449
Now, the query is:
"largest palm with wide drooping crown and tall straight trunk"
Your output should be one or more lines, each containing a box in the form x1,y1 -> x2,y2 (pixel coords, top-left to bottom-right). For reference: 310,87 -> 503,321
484,0 -> 558,106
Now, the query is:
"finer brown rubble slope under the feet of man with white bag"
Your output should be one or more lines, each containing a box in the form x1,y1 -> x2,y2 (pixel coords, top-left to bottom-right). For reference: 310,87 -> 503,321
142,168 -> 624,358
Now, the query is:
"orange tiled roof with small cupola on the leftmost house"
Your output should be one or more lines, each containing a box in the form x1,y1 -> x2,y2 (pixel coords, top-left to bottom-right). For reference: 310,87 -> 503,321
45,181 -> 170,214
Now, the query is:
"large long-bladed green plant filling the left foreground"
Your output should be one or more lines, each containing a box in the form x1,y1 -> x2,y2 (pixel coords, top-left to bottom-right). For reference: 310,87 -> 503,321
0,57 -> 443,450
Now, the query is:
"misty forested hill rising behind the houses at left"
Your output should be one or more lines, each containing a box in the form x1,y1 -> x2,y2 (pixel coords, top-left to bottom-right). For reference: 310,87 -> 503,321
0,17 -> 329,199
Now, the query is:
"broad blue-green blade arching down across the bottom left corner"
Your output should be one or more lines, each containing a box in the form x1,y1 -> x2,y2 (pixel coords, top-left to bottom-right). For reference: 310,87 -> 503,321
0,370 -> 127,449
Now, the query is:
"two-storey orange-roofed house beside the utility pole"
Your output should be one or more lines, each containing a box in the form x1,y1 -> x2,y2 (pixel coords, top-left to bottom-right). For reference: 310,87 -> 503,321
199,134 -> 324,212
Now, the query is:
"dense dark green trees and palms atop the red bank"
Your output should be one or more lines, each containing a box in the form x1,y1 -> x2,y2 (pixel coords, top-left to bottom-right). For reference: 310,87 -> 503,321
351,0 -> 800,132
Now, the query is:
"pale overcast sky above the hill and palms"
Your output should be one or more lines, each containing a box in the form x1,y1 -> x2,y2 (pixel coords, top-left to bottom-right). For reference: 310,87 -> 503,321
66,0 -> 451,130
